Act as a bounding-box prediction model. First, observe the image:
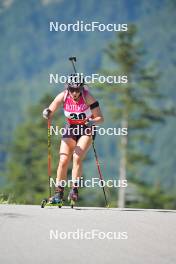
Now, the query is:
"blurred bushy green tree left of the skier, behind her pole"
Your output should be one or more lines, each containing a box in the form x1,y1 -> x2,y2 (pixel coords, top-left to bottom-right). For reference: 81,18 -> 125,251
3,95 -> 62,204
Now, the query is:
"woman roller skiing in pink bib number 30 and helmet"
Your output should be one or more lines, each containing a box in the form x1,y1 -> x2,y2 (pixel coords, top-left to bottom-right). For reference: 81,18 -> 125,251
43,74 -> 104,203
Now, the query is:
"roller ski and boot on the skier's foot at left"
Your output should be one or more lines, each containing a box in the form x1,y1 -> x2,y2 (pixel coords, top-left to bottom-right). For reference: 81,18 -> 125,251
41,187 -> 64,208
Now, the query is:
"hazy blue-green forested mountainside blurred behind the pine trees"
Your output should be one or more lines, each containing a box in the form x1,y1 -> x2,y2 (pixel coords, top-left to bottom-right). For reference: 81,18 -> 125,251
0,0 -> 176,207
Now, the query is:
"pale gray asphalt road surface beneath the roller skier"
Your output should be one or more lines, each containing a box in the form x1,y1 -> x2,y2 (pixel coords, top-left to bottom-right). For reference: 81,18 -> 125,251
0,205 -> 176,264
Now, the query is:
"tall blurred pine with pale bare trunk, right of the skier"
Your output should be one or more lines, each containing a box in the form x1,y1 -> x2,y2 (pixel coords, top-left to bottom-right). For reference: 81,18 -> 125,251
97,25 -> 175,207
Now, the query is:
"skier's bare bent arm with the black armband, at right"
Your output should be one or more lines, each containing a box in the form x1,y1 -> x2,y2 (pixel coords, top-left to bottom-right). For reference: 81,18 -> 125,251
86,93 -> 104,124
